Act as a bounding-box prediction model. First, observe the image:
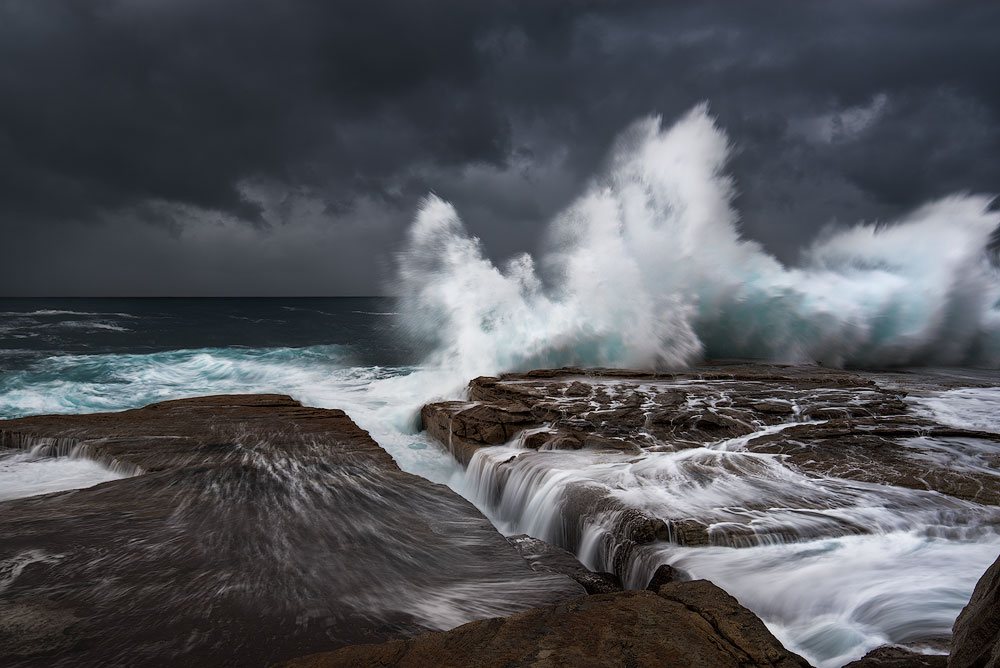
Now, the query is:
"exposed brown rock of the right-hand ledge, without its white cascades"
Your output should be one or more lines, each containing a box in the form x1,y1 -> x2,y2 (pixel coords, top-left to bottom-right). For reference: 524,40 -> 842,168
422,364 -> 1000,551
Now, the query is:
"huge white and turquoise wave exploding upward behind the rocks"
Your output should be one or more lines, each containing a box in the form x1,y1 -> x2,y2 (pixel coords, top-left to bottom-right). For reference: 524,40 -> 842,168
398,105 -> 1000,379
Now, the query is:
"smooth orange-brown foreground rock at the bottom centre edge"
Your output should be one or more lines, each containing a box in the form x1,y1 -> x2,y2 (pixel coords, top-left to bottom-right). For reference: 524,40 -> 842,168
285,580 -> 809,668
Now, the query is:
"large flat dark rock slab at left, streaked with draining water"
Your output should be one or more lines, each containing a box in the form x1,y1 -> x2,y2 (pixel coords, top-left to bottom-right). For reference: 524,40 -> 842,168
0,395 -> 584,666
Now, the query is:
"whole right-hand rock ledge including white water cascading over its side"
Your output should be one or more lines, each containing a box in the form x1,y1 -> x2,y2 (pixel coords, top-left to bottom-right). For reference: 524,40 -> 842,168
421,363 -> 1000,668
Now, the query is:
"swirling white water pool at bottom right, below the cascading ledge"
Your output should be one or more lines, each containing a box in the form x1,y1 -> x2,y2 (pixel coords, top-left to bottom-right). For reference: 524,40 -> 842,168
659,530 -> 1000,668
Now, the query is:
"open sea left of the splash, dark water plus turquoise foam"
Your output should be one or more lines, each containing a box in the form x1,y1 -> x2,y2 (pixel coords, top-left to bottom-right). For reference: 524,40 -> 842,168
0,297 -> 434,418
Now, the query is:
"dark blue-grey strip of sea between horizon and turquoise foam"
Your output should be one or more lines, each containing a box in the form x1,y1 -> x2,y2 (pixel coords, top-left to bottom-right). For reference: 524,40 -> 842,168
0,297 -> 414,372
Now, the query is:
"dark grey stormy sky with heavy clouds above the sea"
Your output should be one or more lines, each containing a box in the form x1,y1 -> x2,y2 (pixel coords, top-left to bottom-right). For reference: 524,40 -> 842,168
0,0 -> 1000,296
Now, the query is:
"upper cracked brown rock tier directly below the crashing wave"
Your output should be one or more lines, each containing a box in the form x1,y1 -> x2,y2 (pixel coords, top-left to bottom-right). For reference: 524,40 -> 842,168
422,364 -> 1000,505
